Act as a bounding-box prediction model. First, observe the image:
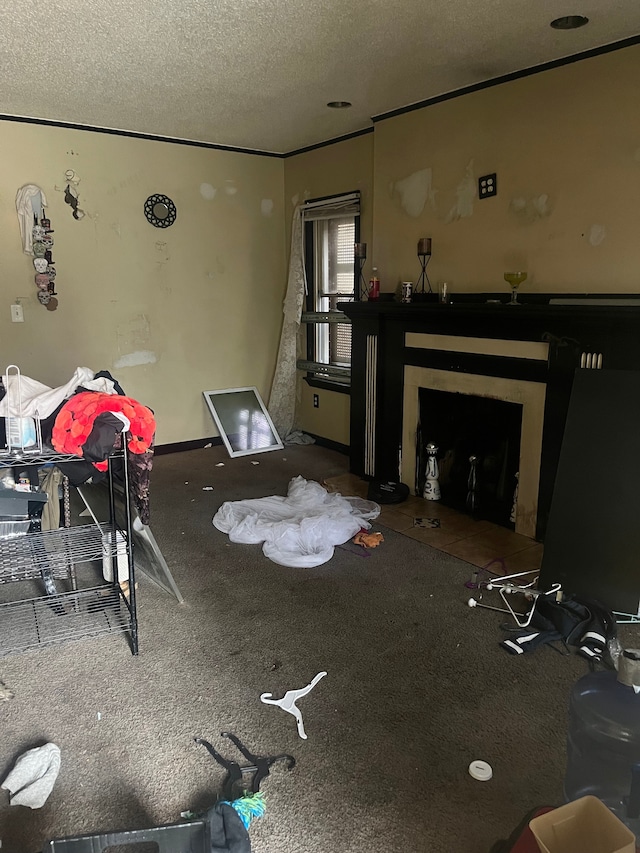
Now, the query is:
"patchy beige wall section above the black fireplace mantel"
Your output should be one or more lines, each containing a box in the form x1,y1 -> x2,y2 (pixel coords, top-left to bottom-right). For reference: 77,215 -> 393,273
373,46 -> 640,300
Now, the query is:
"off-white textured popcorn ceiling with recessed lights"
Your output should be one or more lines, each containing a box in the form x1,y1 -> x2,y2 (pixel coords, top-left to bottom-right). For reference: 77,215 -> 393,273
0,0 -> 640,153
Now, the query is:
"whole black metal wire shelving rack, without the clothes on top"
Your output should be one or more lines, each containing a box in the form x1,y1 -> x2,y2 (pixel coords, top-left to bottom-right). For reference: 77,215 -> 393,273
0,382 -> 138,657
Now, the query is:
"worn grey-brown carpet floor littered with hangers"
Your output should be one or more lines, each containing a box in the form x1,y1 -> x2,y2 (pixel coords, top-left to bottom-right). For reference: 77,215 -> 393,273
0,446 -> 638,853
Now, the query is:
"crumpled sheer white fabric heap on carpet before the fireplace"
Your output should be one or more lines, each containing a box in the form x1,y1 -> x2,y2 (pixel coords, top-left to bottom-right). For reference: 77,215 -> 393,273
213,477 -> 380,569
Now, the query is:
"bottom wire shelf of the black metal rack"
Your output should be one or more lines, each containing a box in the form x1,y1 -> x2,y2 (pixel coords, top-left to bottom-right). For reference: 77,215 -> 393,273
0,585 -> 131,656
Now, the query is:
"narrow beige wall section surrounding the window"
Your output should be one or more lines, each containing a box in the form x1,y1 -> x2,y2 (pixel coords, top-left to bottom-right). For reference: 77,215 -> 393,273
284,133 -> 373,444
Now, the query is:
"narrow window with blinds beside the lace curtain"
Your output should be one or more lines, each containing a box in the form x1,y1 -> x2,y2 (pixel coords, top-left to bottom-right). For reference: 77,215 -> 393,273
299,193 -> 360,386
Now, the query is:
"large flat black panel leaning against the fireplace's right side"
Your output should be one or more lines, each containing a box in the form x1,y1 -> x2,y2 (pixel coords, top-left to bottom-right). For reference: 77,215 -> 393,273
538,369 -> 640,616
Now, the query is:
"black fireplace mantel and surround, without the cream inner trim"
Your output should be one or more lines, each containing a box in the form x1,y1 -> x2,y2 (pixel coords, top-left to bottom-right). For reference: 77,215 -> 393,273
338,293 -> 640,541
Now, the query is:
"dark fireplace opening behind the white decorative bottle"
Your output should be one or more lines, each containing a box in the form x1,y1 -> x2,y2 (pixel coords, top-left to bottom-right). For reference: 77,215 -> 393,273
416,388 -> 522,530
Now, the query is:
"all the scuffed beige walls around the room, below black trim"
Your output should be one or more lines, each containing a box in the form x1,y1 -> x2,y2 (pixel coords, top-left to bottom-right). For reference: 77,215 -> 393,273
0,46 -> 640,444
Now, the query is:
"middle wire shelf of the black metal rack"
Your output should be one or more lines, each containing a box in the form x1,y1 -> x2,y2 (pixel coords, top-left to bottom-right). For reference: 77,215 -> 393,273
0,524 -> 121,584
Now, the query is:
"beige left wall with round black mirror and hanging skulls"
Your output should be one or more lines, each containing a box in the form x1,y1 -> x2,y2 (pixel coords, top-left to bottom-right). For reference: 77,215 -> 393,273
0,122 -> 286,444
